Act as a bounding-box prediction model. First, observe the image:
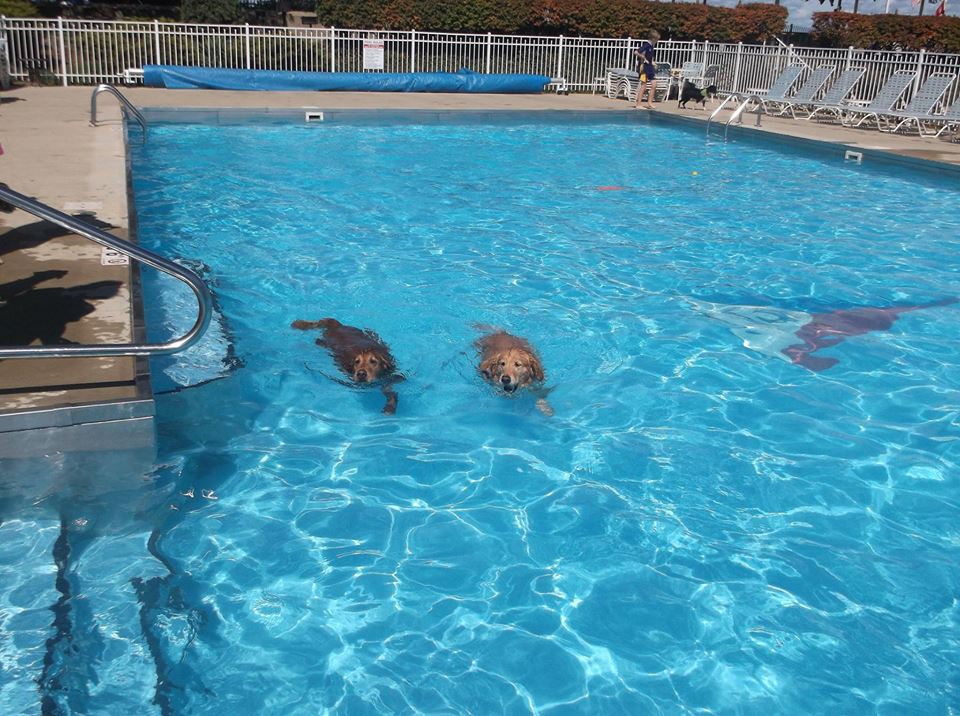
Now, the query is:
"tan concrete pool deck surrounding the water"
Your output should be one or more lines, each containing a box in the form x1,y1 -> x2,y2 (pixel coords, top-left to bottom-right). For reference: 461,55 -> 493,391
0,87 -> 960,457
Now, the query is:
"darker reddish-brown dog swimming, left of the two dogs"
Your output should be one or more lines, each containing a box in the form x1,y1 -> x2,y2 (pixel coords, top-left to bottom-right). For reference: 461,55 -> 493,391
290,318 -> 403,415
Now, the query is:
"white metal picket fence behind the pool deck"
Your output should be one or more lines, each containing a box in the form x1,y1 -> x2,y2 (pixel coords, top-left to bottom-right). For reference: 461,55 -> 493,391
0,17 -> 960,107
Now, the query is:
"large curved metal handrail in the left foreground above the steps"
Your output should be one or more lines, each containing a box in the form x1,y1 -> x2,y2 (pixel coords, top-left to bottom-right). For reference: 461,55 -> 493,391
0,185 -> 213,358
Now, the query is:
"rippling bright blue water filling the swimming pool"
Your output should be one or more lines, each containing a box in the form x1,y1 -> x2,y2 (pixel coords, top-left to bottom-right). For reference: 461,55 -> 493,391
0,117 -> 960,715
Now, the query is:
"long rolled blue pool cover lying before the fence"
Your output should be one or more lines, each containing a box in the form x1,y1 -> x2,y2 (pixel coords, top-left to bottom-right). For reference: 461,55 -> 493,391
143,65 -> 550,94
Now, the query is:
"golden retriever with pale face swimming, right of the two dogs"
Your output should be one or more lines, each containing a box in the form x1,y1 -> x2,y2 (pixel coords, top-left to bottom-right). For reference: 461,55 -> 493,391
473,330 -> 553,415
